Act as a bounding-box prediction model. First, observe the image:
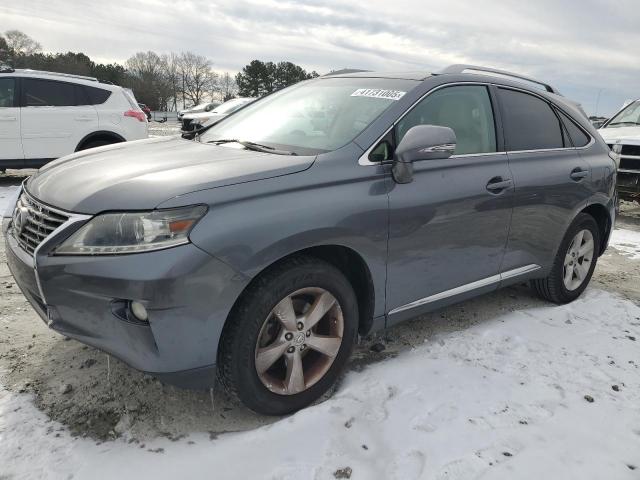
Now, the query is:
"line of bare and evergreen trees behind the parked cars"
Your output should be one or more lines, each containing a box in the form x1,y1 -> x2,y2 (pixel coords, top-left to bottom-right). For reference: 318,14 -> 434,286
0,30 -> 318,111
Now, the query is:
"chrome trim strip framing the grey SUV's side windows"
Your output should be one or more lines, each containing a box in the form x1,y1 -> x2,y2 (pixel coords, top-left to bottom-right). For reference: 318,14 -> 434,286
358,81 -> 596,166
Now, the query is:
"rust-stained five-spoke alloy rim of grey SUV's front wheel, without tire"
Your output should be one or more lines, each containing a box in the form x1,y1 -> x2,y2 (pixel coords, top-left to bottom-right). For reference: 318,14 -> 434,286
255,287 -> 344,395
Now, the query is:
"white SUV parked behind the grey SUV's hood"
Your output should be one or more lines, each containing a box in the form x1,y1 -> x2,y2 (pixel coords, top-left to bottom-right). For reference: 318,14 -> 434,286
0,69 -> 148,171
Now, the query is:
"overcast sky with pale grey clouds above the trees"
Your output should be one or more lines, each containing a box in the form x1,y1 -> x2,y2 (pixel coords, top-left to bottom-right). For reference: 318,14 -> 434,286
0,0 -> 640,115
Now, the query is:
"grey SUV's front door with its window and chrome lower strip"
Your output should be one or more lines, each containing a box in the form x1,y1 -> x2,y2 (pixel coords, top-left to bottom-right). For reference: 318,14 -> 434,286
387,85 -> 513,323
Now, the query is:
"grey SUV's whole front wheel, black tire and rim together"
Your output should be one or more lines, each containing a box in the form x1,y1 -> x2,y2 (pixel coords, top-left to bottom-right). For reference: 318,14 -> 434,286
218,256 -> 358,415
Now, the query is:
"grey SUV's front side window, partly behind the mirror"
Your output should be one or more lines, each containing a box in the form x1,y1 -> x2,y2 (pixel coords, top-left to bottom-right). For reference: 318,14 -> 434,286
396,85 -> 496,155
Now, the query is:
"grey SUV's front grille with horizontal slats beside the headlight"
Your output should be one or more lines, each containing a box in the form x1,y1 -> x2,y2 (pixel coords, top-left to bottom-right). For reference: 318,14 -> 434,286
11,193 -> 69,255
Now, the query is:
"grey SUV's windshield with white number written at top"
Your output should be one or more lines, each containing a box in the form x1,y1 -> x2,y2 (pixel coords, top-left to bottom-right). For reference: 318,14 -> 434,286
200,78 -> 419,155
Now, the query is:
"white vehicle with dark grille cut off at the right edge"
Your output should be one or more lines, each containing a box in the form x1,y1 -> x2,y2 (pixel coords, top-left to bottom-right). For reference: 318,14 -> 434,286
598,99 -> 640,201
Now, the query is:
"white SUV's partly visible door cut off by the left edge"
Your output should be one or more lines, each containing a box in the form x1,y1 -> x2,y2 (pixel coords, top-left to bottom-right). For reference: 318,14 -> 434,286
0,76 -> 24,163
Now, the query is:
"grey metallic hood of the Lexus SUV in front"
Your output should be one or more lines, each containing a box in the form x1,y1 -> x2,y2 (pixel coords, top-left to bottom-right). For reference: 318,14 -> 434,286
26,137 -> 315,214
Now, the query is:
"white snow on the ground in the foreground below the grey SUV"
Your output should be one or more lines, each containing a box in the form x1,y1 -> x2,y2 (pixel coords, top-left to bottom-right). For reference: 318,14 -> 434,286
0,289 -> 640,480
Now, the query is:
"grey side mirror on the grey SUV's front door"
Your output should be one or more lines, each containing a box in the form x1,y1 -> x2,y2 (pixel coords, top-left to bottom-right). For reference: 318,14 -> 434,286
392,125 -> 456,183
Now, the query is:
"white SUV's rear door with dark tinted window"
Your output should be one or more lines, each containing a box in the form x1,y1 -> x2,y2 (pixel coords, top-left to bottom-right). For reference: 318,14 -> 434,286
21,78 -> 98,160
